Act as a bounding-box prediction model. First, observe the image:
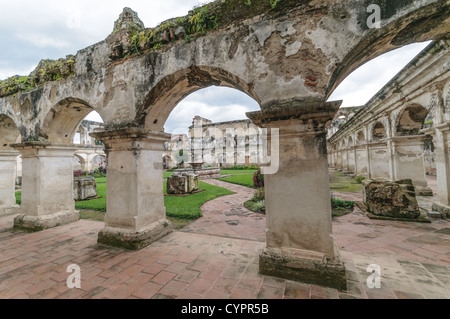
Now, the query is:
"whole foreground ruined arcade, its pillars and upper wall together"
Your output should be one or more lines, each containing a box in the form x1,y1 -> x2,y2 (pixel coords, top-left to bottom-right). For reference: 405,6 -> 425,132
0,0 -> 450,288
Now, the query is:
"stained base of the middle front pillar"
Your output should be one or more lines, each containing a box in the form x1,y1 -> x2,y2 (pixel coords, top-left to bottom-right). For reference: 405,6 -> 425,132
97,220 -> 172,250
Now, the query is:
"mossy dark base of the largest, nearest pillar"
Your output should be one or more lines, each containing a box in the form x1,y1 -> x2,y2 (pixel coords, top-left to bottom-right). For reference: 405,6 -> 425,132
259,249 -> 347,290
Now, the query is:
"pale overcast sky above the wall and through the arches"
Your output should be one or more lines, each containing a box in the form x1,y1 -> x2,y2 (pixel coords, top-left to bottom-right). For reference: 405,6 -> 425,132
0,0 -> 428,133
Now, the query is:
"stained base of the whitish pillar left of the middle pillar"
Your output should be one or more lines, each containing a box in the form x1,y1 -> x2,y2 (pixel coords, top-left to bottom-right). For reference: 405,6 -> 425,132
14,211 -> 80,232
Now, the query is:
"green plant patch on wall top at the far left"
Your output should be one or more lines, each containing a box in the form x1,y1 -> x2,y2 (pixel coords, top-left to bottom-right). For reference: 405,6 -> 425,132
0,55 -> 75,97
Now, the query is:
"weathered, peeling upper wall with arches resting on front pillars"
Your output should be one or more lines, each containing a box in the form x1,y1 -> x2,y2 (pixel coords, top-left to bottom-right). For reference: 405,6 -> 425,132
0,0 -> 449,142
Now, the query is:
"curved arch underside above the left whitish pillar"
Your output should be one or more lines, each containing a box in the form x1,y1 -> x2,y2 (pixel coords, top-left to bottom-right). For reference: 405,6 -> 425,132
40,98 -> 98,144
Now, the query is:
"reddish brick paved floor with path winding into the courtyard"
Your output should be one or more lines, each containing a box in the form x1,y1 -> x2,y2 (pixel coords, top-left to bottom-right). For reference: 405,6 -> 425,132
0,176 -> 450,299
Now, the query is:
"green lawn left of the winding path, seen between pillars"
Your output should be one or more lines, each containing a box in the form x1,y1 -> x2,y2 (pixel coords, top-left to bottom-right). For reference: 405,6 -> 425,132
16,177 -> 233,229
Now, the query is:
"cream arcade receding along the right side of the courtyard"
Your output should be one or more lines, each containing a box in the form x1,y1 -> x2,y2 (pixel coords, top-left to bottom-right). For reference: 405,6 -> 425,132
328,41 -> 450,214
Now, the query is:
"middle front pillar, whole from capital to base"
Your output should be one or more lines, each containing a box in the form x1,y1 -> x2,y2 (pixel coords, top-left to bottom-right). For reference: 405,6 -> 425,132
91,128 -> 172,250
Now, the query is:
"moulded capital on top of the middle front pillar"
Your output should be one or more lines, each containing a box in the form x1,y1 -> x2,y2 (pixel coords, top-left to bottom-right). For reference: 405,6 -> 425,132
90,127 -> 171,151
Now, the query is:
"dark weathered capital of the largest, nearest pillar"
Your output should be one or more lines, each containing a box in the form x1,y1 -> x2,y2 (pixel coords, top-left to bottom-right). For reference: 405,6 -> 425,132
246,101 -> 342,131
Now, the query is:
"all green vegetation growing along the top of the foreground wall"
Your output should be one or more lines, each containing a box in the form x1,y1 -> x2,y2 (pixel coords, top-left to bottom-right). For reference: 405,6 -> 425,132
0,0 -> 299,98
